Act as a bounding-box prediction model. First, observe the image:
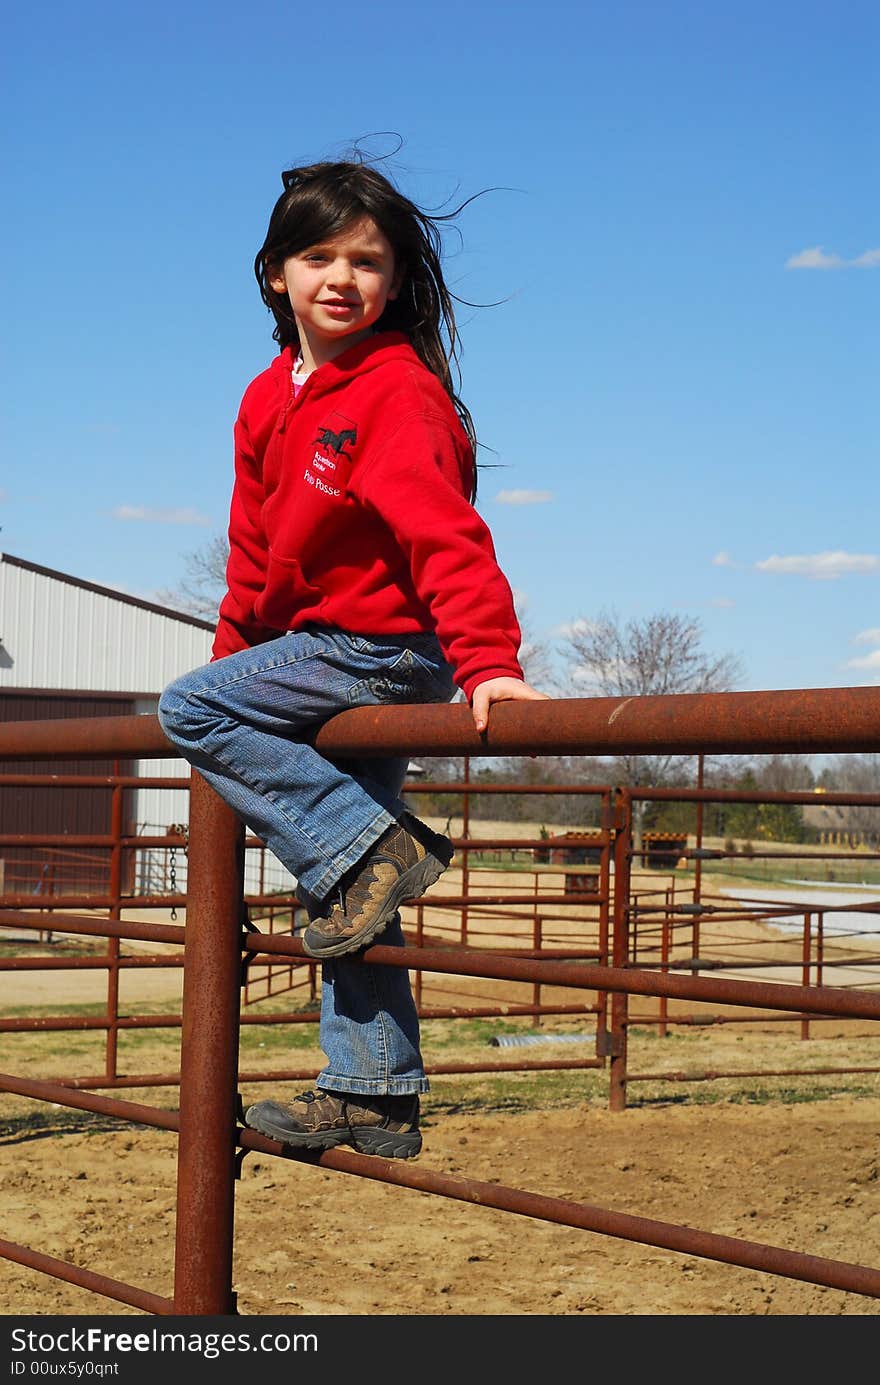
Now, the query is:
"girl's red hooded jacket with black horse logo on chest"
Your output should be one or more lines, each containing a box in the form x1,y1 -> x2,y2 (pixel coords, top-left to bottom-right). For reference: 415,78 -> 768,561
213,332 -> 522,698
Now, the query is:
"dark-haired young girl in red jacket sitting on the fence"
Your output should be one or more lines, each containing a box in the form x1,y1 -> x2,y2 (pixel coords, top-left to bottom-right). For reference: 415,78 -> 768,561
159,162 -> 545,1158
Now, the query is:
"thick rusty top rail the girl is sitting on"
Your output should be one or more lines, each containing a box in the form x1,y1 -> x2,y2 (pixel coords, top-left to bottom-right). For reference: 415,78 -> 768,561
0,687 -> 880,760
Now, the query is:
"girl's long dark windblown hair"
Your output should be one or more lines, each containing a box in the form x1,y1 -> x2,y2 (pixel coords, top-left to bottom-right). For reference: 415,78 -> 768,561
254,162 -> 477,470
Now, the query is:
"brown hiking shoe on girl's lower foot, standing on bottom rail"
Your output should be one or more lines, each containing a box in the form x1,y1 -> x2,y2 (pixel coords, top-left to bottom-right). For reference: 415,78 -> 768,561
244,1090 -> 421,1159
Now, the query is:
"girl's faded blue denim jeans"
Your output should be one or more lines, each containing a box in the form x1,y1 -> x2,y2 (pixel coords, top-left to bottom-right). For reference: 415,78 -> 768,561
158,626 -> 455,1096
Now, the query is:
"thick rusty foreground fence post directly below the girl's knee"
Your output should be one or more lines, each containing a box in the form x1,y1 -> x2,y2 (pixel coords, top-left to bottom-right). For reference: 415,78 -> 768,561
175,773 -> 244,1316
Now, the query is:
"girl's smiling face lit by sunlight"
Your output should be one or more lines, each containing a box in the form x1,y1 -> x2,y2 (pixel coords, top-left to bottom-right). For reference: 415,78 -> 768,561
269,216 -> 403,370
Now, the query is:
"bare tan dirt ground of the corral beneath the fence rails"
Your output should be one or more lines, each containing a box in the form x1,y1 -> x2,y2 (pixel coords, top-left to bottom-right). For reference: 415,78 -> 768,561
0,842 -> 880,1317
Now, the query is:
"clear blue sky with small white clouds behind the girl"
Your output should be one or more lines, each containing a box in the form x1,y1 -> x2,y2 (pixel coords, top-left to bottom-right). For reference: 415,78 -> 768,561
0,0 -> 880,688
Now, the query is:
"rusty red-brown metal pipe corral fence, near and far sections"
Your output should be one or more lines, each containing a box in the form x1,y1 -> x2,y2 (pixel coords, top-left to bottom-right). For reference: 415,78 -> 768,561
0,688 -> 880,1314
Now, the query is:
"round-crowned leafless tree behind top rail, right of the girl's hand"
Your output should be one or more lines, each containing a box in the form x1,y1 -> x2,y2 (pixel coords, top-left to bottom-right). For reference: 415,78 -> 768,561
563,612 -> 741,837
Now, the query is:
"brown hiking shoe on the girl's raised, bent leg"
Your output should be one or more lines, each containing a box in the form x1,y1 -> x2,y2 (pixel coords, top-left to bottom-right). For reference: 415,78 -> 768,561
302,813 -> 453,960
